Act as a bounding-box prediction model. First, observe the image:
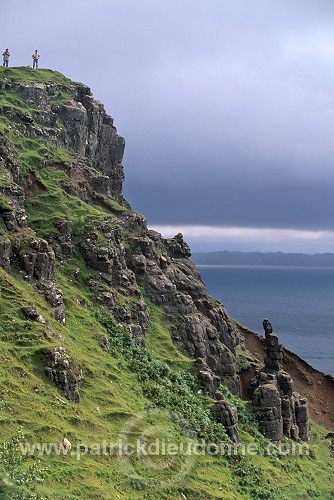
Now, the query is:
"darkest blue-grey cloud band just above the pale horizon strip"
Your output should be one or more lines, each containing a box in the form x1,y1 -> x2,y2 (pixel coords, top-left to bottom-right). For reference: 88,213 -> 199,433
126,178 -> 334,230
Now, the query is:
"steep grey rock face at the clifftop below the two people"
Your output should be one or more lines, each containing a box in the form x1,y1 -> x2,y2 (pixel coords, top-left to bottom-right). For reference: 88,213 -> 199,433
0,82 -> 129,206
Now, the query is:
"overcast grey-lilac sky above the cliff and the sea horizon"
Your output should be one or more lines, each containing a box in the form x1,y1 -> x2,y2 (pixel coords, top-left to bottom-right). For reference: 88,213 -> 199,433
0,0 -> 334,253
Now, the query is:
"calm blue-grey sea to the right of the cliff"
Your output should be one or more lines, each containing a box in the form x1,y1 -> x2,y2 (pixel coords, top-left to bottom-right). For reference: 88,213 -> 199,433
197,265 -> 334,375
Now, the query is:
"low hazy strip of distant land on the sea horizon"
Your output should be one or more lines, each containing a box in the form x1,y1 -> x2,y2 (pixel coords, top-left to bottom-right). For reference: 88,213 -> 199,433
192,250 -> 334,267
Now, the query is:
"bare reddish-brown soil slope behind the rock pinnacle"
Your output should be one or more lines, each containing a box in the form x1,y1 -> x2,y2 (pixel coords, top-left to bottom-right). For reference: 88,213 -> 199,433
237,325 -> 334,431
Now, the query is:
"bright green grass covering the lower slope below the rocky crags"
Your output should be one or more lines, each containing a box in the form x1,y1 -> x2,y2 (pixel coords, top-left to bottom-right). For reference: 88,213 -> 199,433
0,264 -> 334,499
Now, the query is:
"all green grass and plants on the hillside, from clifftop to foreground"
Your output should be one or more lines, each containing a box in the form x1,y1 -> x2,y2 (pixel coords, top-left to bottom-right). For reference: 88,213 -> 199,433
0,67 -> 334,500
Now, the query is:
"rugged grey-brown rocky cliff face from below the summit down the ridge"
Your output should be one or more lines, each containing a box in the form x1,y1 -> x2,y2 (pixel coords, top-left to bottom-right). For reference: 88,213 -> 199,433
0,69 -> 312,440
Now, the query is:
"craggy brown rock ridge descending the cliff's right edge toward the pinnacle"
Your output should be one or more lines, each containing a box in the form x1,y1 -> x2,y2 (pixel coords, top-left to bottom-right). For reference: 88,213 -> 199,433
127,226 -> 242,395
